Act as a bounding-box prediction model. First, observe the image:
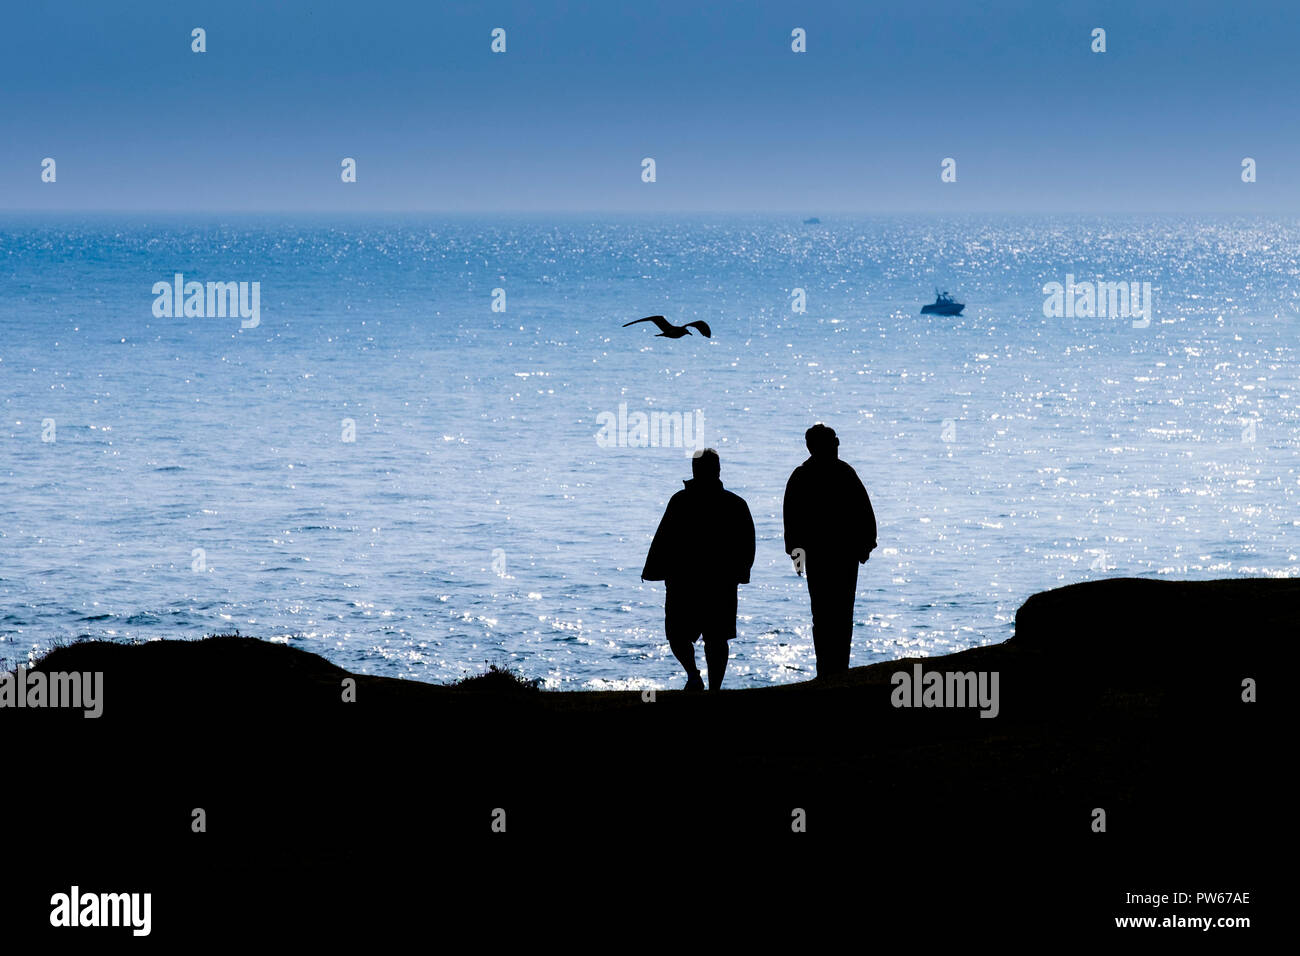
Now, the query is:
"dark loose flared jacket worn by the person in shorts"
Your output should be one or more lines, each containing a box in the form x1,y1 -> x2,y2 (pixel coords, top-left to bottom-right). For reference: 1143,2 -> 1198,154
641,479 -> 754,587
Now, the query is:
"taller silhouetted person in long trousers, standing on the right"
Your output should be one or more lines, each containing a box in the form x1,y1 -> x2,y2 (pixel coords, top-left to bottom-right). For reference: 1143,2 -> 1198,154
785,423 -> 876,678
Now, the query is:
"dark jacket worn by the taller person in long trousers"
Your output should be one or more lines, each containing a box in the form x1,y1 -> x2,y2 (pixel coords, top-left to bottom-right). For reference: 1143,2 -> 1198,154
784,457 -> 876,563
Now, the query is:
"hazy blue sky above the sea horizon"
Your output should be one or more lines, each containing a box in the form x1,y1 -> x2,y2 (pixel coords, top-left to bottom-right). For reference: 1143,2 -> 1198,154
0,0 -> 1300,215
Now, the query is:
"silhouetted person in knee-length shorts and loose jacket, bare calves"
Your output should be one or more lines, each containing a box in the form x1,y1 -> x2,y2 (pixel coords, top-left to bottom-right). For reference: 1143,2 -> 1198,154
641,449 -> 754,691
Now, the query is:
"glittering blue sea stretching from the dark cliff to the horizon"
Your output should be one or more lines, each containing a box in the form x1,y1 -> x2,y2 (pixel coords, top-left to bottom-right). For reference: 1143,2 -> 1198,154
0,212 -> 1300,689
